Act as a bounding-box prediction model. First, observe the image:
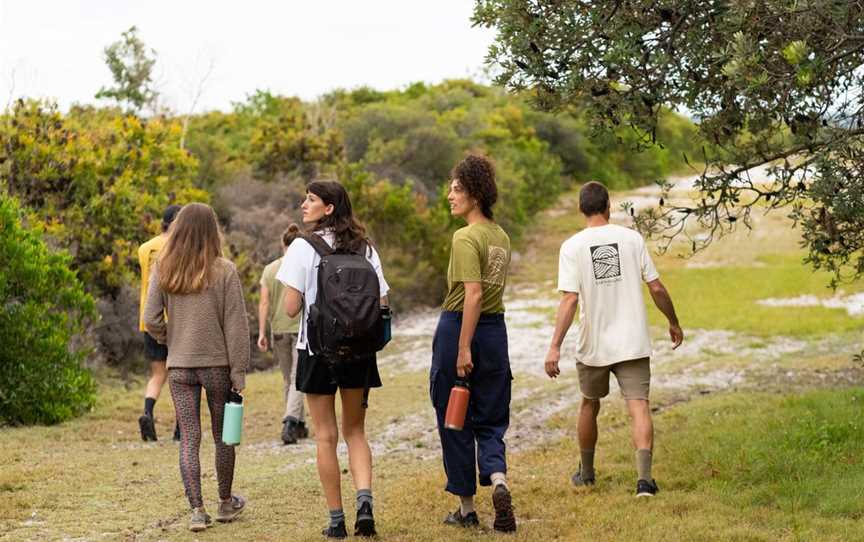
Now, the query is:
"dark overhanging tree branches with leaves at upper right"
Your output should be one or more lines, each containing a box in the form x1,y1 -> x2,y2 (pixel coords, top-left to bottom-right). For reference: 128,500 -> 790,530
474,0 -> 864,286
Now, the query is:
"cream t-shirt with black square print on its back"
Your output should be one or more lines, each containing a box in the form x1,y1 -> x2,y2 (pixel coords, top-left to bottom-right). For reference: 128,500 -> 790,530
558,224 -> 660,367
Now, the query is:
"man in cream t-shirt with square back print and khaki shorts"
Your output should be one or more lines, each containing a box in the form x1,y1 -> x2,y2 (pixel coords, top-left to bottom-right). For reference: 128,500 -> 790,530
545,182 -> 684,497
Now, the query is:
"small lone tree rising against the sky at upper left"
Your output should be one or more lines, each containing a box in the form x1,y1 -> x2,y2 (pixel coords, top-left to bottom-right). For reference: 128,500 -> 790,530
96,26 -> 157,113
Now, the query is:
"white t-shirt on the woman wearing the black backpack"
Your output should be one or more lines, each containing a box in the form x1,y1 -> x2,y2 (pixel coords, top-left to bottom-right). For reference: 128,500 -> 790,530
276,232 -> 390,352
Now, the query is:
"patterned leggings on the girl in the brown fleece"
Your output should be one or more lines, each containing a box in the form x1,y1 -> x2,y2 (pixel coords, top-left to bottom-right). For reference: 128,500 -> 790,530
168,367 -> 234,508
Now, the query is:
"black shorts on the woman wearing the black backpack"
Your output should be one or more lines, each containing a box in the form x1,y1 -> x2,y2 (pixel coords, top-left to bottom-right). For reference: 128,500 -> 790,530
297,350 -> 381,395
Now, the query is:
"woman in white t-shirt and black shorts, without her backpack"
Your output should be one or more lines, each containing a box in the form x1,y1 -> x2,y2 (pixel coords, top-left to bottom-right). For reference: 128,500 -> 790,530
276,180 -> 389,538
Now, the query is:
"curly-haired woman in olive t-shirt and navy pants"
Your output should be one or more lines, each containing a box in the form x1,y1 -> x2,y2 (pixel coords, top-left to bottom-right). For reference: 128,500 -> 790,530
429,155 -> 516,532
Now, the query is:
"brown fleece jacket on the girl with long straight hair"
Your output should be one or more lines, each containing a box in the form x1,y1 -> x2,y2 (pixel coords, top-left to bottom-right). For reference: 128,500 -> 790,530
144,258 -> 249,390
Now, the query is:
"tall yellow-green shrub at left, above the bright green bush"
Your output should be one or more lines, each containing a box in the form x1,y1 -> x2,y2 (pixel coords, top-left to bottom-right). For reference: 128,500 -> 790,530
0,100 -> 209,295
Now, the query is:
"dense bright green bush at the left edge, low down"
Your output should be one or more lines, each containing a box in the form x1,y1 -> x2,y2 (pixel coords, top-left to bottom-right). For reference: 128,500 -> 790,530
0,193 -> 95,424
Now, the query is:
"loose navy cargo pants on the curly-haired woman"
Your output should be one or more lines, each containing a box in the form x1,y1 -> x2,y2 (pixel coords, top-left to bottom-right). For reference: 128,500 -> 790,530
429,312 -> 513,497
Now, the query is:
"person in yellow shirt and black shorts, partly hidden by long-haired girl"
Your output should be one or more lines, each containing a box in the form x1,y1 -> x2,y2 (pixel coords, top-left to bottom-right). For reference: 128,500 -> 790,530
138,205 -> 180,441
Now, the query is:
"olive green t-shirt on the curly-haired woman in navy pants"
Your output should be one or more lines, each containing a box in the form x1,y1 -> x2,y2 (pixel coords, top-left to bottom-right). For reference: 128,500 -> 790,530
442,222 -> 510,314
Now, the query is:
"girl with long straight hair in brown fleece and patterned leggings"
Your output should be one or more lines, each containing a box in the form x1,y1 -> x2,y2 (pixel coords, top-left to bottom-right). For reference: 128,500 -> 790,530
144,203 -> 249,531
